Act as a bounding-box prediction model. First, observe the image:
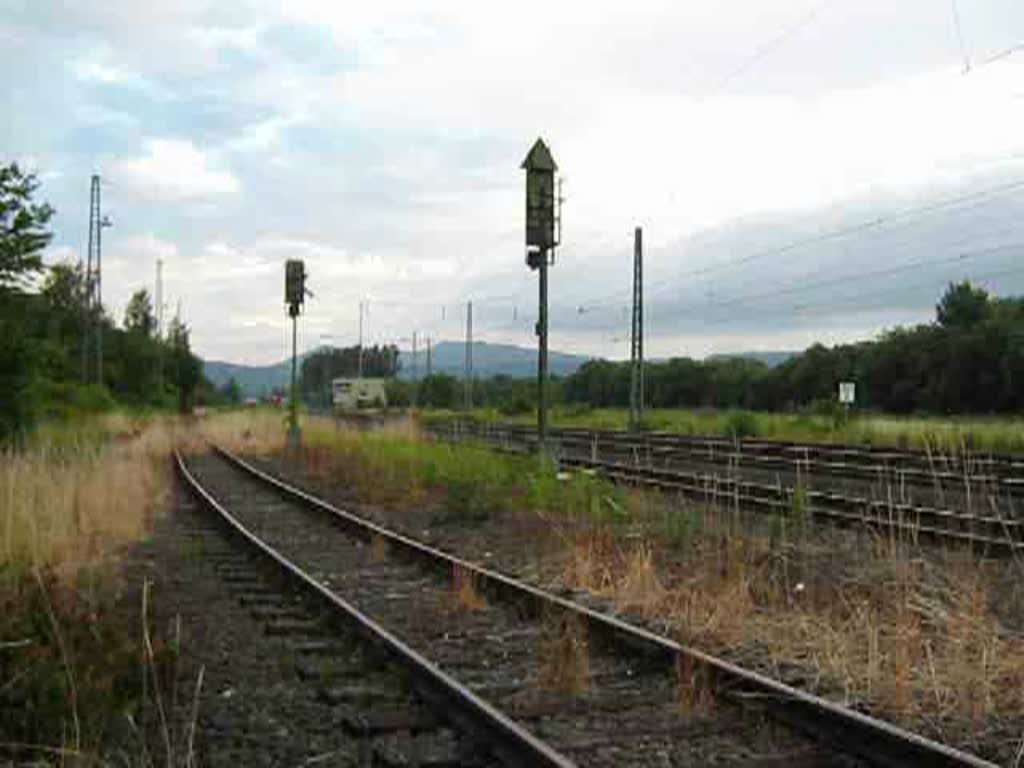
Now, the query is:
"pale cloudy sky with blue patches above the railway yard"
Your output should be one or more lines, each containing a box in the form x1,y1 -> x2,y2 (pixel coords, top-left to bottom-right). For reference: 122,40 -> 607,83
0,0 -> 1024,364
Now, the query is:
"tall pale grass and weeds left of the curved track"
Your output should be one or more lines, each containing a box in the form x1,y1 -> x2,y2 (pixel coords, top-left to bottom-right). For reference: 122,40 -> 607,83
0,415 -> 177,760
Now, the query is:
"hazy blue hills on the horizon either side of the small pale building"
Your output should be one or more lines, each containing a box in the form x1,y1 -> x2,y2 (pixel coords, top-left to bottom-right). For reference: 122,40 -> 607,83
203,341 -> 590,397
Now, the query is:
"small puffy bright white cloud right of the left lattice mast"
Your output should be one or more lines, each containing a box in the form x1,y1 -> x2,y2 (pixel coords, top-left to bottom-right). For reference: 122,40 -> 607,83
112,138 -> 242,203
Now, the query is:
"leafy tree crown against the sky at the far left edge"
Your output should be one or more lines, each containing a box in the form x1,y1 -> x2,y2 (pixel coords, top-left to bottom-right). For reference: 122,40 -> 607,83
0,163 -> 53,294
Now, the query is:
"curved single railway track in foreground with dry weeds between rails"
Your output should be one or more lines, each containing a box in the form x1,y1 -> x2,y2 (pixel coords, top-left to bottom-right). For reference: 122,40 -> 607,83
177,452 -> 990,768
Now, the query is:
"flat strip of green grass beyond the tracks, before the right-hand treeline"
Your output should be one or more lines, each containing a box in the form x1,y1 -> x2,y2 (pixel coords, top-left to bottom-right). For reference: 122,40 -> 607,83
425,406 -> 1024,453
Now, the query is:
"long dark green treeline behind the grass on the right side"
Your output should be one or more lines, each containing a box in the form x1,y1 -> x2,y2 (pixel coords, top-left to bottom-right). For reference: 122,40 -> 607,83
563,283 -> 1024,417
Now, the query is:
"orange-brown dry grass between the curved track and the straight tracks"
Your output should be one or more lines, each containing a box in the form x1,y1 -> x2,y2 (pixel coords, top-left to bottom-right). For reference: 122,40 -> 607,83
559,498 -> 1024,749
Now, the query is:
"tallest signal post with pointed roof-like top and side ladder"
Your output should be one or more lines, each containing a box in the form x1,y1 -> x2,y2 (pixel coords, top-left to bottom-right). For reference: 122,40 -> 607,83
520,138 -> 561,453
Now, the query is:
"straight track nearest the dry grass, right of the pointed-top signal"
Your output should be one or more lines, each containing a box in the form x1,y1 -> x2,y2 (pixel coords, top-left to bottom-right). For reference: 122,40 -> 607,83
434,424 -> 1024,554
